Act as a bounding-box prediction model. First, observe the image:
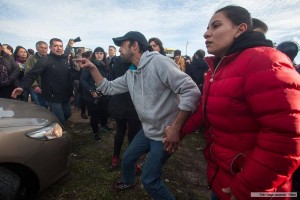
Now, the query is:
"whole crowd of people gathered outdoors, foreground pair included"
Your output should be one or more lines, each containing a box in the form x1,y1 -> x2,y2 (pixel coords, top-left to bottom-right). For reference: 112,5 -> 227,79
0,5 -> 300,200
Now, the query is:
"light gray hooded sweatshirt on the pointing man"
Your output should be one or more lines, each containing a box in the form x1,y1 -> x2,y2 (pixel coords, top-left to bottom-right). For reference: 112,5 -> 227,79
97,51 -> 200,141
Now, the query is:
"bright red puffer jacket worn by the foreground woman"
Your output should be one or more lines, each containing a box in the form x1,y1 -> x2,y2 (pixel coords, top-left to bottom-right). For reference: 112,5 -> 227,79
182,47 -> 300,199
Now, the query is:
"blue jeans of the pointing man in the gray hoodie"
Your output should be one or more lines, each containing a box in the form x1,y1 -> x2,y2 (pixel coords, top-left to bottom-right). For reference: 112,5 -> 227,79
121,129 -> 175,200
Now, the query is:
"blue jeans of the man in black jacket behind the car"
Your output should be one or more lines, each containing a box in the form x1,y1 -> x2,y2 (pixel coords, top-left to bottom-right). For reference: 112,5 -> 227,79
47,101 -> 71,125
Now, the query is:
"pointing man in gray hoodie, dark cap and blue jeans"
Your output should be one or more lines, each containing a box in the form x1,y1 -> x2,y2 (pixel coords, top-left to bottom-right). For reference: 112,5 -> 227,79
74,31 -> 200,200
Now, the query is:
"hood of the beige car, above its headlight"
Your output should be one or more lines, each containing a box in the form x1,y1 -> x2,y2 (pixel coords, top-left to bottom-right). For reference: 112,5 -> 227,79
0,98 -> 58,128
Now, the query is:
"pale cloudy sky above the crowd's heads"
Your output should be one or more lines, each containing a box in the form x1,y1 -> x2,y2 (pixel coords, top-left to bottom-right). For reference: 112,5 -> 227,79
0,0 -> 300,63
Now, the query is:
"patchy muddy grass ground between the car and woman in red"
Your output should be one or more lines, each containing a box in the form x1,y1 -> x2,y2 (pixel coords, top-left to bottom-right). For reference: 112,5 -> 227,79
39,122 -> 208,200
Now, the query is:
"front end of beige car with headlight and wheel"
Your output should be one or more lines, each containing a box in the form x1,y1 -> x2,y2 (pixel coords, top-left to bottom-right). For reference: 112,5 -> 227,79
0,98 -> 71,200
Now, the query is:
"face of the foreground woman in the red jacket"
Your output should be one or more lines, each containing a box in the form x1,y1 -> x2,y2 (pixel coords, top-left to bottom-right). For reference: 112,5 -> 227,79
204,12 -> 240,57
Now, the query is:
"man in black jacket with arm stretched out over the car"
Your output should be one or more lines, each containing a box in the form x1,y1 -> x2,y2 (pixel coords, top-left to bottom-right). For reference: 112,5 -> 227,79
12,38 -> 74,124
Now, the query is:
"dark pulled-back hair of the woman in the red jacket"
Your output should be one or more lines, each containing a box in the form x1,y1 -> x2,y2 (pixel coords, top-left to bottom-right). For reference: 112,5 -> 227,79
215,5 -> 253,30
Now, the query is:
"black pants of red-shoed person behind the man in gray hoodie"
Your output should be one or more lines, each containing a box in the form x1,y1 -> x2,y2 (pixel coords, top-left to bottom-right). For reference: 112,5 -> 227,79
114,118 -> 142,156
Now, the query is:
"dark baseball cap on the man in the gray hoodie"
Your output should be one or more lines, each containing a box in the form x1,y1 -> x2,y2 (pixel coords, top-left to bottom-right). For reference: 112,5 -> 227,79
113,31 -> 149,51
